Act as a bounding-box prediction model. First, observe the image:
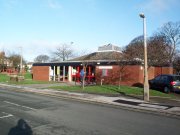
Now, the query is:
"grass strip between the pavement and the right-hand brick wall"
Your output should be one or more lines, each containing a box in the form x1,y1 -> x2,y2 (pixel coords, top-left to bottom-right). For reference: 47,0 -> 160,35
49,85 -> 179,98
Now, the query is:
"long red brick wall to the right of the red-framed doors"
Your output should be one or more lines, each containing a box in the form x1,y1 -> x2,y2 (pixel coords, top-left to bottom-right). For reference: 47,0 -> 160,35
95,65 -> 173,86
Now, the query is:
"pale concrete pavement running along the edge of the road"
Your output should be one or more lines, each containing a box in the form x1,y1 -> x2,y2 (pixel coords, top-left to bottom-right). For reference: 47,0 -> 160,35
0,84 -> 180,117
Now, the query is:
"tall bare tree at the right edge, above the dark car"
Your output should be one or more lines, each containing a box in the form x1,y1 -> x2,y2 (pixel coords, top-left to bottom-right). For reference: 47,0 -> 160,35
158,22 -> 180,64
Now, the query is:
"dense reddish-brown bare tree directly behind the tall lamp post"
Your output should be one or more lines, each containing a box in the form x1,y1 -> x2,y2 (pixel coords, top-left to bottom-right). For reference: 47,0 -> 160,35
123,35 -> 172,67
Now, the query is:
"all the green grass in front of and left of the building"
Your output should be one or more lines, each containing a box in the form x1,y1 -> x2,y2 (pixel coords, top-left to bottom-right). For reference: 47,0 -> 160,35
0,73 -> 180,99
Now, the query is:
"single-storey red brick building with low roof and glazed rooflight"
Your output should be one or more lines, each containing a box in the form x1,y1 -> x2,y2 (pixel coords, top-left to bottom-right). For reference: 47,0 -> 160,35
33,44 -> 173,86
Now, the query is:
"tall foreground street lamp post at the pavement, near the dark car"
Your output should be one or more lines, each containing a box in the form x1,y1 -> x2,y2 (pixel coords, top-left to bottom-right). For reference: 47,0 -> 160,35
139,13 -> 149,101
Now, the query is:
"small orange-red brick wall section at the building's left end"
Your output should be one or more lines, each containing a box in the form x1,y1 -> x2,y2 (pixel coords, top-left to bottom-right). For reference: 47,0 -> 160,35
32,66 -> 49,81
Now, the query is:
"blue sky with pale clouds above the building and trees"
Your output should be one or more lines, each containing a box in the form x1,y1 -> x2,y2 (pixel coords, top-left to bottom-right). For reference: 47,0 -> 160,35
0,0 -> 180,61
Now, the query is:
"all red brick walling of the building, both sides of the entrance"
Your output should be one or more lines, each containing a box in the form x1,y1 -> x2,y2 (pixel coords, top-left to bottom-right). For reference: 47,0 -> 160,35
33,65 -> 173,86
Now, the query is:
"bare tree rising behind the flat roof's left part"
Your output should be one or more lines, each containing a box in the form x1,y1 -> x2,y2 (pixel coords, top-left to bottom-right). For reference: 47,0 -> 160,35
53,44 -> 74,61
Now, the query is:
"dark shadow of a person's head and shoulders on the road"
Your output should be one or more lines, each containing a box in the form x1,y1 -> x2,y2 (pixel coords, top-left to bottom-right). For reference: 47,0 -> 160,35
8,119 -> 33,135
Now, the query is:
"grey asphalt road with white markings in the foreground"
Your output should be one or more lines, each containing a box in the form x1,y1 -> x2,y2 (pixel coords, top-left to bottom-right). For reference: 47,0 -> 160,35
0,88 -> 180,135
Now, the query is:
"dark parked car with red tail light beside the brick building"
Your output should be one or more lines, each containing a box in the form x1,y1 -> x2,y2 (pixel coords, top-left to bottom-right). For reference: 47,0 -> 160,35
149,74 -> 180,93
